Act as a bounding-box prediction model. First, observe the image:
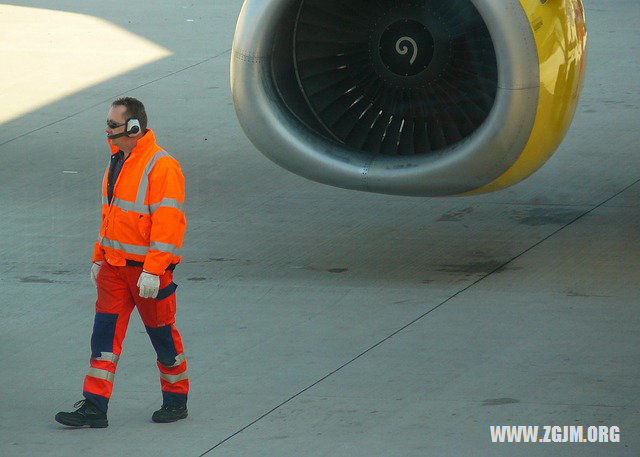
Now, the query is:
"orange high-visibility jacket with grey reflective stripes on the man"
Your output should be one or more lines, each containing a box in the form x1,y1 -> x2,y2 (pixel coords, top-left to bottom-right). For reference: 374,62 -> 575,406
93,129 -> 187,275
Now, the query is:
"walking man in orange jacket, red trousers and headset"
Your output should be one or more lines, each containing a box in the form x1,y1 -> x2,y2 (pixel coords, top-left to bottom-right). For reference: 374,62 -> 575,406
55,97 -> 189,427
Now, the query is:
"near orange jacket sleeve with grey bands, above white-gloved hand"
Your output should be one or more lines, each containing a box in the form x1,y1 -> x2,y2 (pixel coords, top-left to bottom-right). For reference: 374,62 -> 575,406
143,156 -> 187,275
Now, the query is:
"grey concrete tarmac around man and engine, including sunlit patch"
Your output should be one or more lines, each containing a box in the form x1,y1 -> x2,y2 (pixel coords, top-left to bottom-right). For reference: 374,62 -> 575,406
0,0 -> 640,457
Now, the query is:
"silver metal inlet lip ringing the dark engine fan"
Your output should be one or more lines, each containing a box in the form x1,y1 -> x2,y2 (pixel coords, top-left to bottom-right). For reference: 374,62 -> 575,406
230,0 -> 540,196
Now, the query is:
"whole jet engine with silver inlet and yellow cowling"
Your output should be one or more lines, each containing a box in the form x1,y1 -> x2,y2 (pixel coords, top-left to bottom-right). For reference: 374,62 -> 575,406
231,0 -> 586,196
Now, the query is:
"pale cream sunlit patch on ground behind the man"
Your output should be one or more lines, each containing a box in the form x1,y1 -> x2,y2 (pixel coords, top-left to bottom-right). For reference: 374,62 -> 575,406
0,5 -> 171,123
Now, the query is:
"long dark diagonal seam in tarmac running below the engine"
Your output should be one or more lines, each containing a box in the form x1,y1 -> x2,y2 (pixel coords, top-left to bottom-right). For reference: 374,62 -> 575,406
198,179 -> 640,457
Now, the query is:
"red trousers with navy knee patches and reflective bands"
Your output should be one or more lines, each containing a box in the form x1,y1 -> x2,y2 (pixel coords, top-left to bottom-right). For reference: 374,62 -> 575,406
83,262 -> 189,412
